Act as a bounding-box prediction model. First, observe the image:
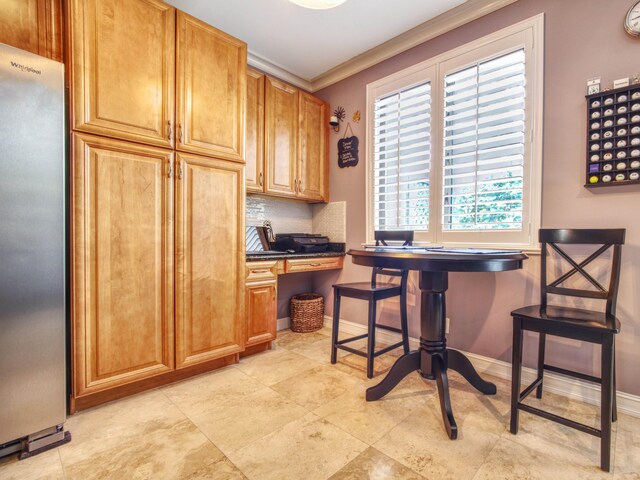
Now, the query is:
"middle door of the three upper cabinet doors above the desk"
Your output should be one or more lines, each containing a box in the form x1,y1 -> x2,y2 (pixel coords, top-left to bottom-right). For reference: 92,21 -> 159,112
265,77 -> 298,197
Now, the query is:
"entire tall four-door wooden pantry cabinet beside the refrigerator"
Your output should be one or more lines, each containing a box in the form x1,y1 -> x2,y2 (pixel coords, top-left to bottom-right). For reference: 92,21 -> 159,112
67,0 -> 247,411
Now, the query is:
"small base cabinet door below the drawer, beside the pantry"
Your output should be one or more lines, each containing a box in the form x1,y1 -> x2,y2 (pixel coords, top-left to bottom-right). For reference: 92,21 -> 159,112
246,281 -> 277,347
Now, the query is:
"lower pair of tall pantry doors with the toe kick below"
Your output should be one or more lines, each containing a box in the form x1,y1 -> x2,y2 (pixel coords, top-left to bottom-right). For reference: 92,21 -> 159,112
71,133 -> 245,411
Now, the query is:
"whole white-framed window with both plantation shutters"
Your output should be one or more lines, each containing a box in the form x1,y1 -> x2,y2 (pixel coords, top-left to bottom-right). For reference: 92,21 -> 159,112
367,15 -> 544,249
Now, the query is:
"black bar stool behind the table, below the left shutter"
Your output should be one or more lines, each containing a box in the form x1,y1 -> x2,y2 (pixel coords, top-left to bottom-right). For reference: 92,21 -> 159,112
331,231 -> 413,378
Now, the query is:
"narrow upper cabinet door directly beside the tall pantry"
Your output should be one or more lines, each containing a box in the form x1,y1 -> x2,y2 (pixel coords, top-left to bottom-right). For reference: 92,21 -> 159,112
245,68 -> 264,192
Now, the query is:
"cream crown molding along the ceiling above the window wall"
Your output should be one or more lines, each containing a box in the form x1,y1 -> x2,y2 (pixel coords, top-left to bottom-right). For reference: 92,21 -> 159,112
310,0 -> 517,92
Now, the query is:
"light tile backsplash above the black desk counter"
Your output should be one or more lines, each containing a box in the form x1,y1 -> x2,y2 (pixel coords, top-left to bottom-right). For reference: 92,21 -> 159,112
246,195 -> 347,243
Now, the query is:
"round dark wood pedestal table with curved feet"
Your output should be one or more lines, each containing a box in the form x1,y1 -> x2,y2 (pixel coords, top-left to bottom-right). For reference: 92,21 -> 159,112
347,247 -> 528,440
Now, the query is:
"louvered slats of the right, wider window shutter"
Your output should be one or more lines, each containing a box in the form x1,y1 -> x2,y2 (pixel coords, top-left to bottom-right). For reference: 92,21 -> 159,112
442,49 -> 525,230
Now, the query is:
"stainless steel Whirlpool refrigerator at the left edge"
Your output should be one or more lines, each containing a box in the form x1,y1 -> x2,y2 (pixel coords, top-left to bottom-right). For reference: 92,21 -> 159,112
0,44 -> 69,457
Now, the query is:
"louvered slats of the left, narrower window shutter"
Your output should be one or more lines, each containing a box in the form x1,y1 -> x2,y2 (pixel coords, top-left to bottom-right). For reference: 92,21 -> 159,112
373,82 -> 431,230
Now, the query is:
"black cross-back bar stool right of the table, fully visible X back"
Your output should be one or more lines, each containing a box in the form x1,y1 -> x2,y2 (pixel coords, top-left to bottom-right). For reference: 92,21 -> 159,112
511,228 -> 625,472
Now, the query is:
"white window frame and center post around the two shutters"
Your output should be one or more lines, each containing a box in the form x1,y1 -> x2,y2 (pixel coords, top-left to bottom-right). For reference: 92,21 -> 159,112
366,14 -> 544,252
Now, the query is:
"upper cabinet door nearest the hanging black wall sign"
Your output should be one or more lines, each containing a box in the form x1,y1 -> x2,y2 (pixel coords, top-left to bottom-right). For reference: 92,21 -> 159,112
298,92 -> 329,201
